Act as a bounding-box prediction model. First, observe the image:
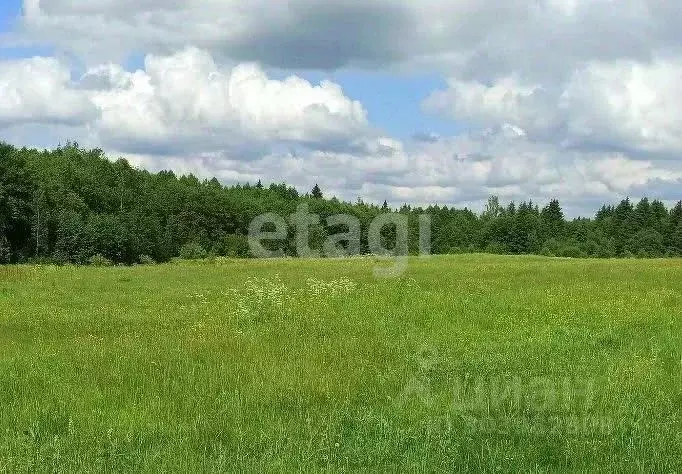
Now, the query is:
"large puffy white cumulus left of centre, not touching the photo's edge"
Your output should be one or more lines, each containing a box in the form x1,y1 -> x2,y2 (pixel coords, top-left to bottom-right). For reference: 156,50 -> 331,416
81,48 -> 368,153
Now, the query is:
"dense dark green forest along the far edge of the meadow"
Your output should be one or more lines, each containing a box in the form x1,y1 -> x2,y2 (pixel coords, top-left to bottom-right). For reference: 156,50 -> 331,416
0,143 -> 682,264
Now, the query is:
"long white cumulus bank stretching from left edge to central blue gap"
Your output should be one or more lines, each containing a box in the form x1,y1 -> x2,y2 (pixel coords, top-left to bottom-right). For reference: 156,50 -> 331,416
0,48 -> 370,153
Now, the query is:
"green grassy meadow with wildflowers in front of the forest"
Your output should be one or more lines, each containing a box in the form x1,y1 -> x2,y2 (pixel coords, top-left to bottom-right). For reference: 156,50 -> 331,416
0,255 -> 682,472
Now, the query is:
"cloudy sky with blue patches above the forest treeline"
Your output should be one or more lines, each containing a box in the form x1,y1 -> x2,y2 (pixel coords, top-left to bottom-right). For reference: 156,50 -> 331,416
0,0 -> 682,215
